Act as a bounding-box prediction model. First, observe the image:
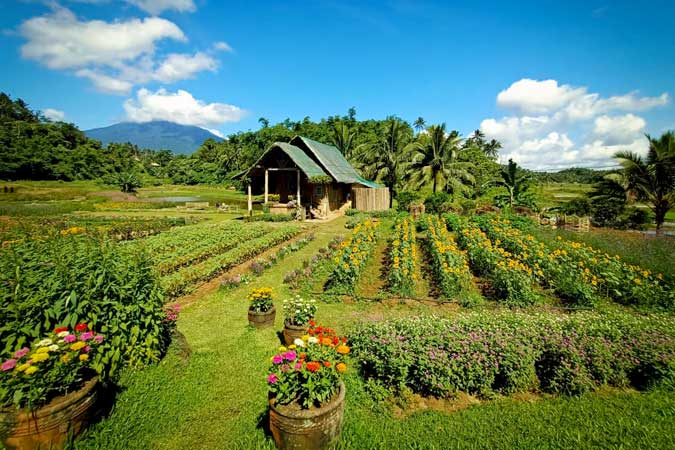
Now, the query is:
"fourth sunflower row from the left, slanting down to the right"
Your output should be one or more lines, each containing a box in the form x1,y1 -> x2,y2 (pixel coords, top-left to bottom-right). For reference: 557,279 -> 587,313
450,216 -> 539,306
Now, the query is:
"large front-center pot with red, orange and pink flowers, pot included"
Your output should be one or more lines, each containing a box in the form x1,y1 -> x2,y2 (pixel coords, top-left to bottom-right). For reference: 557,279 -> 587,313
267,326 -> 350,450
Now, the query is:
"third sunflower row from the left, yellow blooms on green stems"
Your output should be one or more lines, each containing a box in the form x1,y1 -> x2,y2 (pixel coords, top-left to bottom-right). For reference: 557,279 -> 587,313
426,216 -> 471,298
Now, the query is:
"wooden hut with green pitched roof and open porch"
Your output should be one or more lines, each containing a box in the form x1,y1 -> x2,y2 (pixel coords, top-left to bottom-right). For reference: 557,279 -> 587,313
239,136 -> 389,218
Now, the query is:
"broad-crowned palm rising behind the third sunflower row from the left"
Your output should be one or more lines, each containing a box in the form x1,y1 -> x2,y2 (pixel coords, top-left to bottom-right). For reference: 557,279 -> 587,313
408,124 -> 475,194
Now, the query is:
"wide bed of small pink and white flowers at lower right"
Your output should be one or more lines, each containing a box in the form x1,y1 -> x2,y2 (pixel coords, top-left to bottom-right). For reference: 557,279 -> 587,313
349,311 -> 675,397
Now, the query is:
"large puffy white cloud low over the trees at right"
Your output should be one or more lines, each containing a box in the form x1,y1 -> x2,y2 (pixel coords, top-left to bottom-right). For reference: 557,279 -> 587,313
480,79 -> 670,170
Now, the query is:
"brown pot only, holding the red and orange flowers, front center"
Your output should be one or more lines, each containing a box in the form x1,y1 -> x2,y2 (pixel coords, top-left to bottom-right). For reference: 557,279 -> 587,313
270,382 -> 346,450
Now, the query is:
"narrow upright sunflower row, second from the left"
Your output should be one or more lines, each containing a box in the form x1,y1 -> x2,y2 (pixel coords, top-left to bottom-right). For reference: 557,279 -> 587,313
387,216 -> 418,296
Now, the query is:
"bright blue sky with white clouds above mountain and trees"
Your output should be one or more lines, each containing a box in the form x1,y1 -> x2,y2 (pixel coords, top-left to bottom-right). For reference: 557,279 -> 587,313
0,0 -> 675,170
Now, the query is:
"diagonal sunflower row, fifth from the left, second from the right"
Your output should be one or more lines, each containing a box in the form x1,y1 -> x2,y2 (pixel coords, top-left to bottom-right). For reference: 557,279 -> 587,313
476,216 -> 603,306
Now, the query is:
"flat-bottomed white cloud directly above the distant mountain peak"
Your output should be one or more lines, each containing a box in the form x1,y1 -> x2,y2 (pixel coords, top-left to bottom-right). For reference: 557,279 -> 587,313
124,88 -> 245,128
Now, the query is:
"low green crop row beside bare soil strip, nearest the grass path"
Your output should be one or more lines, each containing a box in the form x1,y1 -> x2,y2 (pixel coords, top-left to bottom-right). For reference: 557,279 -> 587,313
162,225 -> 299,298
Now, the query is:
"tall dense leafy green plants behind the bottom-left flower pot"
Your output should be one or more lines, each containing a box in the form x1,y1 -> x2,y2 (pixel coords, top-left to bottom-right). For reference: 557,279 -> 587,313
0,234 -> 170,376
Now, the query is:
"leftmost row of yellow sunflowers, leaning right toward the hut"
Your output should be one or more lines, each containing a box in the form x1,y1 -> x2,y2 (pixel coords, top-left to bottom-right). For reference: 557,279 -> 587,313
328,219 -> 380,293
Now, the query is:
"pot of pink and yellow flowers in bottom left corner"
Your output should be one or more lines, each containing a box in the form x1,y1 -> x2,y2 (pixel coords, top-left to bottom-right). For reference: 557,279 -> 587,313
0,323 -> 104,450
